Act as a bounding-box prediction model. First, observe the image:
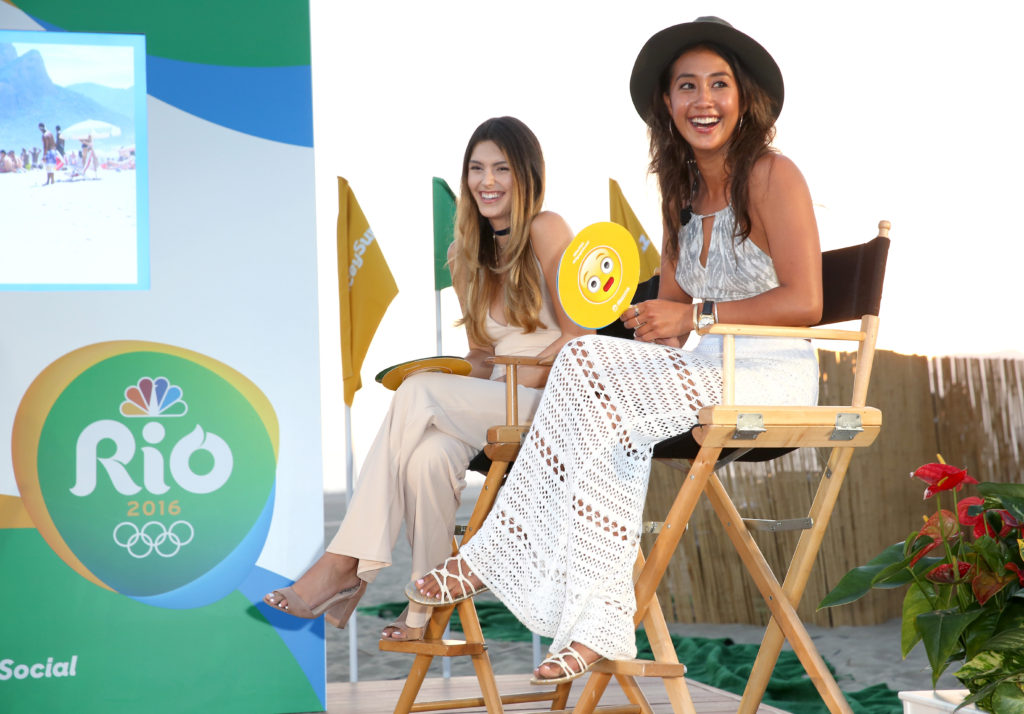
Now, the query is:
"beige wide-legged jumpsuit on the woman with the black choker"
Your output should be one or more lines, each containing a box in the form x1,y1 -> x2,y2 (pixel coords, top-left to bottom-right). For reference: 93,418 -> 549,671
328,281 -> 561,627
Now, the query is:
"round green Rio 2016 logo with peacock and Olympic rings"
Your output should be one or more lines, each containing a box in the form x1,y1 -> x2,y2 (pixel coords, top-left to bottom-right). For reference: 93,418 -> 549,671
12,341 -> 278,608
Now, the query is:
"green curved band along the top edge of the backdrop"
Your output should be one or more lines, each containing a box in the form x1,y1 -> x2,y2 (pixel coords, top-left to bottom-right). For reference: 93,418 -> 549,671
10,0 -> 309,67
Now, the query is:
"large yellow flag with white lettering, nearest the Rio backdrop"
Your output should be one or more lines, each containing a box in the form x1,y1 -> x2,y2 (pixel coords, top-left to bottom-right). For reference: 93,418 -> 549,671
338,176 -> 398,407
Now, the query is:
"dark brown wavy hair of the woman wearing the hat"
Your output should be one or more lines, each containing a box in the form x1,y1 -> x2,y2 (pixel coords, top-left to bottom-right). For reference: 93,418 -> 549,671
647,43 -> 775,260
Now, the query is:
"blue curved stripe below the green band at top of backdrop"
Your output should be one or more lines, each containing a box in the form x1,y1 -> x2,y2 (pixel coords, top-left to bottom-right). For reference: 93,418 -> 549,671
145,55 -> 313,146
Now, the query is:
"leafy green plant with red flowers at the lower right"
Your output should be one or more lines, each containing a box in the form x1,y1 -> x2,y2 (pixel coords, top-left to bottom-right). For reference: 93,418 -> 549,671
819,456 -> 1024,714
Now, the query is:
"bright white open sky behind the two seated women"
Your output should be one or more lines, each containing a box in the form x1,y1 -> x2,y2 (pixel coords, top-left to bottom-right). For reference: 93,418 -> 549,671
311,0 -> 1024,490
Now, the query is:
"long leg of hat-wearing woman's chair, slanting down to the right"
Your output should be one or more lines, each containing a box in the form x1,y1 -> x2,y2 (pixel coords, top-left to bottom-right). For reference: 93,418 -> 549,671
706,474 -> 853,714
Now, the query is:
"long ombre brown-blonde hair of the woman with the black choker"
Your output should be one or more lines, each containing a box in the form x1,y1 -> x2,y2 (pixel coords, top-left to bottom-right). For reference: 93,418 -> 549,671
450,117 -> 547,344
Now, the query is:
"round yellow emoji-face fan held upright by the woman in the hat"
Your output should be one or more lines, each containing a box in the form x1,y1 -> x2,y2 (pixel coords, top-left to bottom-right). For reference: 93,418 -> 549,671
558,222 -> 640,330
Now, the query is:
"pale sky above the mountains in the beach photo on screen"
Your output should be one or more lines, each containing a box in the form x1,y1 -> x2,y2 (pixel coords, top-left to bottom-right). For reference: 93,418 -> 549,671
12,42 -> 135,89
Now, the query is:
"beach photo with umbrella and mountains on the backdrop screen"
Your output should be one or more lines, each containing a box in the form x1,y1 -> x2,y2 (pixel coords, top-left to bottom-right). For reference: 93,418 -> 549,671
0,30 -> 150,290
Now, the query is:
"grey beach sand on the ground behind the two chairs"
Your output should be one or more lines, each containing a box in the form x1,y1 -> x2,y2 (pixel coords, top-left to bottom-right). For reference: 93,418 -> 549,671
325,486 -> 962,691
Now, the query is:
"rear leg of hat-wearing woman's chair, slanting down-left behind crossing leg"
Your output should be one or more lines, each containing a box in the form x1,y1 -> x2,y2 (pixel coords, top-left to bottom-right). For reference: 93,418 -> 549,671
739,448 -> 853,714
